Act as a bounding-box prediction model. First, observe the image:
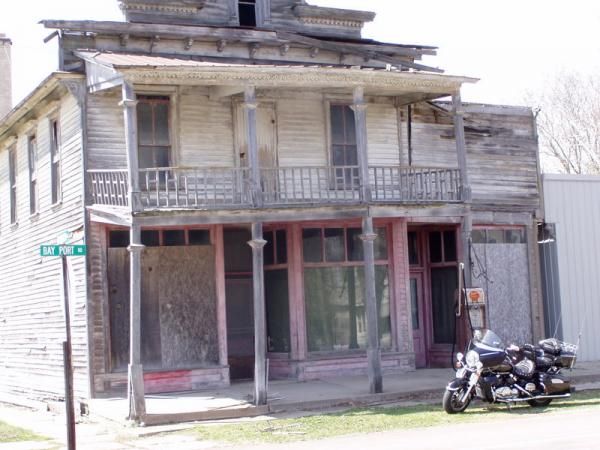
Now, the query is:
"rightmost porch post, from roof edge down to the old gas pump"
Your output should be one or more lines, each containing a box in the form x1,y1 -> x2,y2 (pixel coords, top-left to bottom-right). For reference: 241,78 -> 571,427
452,91 -> 473,287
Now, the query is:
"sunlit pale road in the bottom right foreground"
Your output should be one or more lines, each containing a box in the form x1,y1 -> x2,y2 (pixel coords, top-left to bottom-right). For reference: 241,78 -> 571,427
237,407 -> 600,450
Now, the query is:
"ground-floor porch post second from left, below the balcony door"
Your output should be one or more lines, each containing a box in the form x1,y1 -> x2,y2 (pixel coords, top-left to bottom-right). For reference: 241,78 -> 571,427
248,223 -> 268,406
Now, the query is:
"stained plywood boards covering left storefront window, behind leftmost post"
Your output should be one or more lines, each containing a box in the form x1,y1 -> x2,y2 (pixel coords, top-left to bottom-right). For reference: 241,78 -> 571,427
108,245 -> 219,371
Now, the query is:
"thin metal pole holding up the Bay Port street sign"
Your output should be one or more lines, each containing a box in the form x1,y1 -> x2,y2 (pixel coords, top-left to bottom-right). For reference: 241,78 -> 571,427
61,254 -> 77,450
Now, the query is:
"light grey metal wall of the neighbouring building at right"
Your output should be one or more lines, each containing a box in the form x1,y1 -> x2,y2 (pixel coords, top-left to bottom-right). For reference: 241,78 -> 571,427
543,175 -> 600,361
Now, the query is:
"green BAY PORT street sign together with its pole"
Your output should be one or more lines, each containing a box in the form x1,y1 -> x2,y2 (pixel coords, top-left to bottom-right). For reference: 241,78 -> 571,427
40,244 -> 87,450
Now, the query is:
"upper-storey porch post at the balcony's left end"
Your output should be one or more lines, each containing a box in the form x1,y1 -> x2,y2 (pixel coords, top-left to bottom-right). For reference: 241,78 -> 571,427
120,81 -> 142,212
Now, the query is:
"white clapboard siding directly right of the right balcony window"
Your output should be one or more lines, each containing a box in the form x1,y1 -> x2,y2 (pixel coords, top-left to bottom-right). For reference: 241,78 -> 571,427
367,104 -> 401,166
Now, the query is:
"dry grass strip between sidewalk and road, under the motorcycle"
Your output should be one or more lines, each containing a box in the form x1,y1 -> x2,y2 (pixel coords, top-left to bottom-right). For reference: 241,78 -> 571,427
193,391 -> 600,444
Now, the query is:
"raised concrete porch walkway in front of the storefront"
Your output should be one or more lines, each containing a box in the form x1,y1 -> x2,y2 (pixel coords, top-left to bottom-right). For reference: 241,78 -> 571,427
89,362 -> 600,426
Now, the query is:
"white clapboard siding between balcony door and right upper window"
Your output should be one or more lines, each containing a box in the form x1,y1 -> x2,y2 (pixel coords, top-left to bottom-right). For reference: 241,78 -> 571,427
277,97 -> 329,167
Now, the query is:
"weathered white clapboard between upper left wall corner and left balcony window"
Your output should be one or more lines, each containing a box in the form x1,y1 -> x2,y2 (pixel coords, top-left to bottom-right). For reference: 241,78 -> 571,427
86,93 -> 127,169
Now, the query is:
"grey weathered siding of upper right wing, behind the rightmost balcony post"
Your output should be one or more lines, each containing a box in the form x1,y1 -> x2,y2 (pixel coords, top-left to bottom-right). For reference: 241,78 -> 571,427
412,102 -> 539,211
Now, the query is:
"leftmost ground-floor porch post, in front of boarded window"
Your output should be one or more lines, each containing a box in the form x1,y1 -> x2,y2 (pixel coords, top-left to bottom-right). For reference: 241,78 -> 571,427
127,223 -> 146,422
